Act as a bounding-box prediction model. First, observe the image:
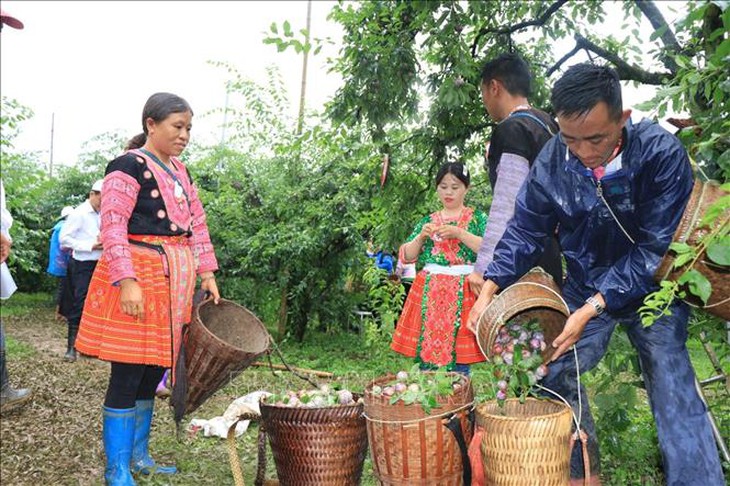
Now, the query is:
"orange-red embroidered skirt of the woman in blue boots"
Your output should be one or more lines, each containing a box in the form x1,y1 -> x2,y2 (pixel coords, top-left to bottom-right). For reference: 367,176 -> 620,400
76,235 -> 195,368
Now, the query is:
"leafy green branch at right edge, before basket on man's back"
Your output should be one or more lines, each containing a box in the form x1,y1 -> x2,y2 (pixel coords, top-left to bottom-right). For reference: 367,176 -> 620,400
639,183 -> 730,326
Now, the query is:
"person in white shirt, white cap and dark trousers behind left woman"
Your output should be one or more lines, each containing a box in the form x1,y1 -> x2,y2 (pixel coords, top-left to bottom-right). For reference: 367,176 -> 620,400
59,180 -> 103,362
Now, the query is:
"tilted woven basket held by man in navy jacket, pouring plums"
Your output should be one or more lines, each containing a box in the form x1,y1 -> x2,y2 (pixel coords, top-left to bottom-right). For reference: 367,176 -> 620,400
476,267 -> 570,363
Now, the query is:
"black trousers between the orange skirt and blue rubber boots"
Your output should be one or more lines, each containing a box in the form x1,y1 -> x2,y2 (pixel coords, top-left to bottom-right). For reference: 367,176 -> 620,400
104,362 -> 165,409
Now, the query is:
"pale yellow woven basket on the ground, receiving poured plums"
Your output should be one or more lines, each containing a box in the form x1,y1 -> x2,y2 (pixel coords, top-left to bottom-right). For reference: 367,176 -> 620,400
476,398 -> 572,486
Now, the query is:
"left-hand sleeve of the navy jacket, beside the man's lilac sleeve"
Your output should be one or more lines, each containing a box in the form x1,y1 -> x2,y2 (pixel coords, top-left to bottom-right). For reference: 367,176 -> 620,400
484,165 -> 557,289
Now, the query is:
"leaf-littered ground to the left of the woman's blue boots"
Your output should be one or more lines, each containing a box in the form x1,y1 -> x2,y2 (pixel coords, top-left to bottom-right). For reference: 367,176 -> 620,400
0,310 -> 115,485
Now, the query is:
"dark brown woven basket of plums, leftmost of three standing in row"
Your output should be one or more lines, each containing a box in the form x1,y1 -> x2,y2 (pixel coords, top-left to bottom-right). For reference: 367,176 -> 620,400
261,400 -> 368,486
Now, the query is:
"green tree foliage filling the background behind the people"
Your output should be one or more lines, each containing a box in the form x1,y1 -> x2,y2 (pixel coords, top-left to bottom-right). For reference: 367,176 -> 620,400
0,0 -> 730,339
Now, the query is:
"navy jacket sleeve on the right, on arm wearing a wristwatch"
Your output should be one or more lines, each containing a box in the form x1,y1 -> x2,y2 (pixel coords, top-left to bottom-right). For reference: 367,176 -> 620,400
593,139 -> 693,310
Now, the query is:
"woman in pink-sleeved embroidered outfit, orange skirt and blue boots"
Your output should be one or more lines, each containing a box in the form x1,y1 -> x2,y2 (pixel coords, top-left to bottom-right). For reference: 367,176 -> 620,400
76,93 -> 220,486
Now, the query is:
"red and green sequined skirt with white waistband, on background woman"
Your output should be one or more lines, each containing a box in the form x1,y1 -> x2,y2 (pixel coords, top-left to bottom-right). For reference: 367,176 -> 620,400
390,271 -> 486,366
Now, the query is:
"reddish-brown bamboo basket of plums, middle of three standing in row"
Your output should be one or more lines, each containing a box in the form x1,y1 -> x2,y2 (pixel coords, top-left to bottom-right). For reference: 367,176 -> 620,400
365,375 -> 474,486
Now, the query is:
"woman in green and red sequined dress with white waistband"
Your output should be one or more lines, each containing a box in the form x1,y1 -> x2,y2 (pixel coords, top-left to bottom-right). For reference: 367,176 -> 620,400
391,163 -> 487,374
